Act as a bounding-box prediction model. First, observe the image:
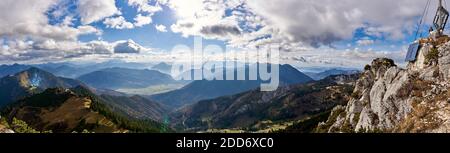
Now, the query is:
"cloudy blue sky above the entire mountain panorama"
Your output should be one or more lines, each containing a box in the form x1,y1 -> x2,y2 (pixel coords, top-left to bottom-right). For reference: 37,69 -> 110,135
0,0 -> 446,68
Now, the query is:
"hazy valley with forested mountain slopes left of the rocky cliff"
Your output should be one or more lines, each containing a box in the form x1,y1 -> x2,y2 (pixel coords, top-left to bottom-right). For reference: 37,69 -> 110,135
0,61 -> 357,133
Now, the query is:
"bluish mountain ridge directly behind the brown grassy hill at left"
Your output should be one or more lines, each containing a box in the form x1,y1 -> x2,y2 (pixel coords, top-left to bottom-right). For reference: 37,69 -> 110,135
0,67 -> 170,124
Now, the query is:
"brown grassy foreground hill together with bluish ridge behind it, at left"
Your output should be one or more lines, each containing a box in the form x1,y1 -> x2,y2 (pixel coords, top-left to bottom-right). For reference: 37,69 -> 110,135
0,67 -> 175,133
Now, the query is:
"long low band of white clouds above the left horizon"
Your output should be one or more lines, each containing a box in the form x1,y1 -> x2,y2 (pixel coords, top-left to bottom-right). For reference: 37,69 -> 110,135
0,39 -> 151,63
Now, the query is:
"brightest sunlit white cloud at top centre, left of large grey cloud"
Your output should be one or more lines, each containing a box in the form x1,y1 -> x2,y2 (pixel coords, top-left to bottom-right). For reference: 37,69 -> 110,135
167,0 -> 246,41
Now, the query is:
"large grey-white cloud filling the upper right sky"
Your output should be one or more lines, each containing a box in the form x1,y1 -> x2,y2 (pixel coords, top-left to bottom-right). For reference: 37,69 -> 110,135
247,0 -> 426,47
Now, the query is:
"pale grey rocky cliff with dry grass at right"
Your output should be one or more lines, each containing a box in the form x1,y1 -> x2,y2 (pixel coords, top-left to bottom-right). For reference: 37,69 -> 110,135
318,43 -> 450,133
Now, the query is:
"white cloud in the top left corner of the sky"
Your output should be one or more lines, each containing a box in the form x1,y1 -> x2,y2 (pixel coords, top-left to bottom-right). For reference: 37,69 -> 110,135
0,0 -> 101,40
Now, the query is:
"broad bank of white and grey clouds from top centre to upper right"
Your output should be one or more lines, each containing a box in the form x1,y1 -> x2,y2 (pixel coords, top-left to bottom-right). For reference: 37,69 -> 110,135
161,0 -> 432,48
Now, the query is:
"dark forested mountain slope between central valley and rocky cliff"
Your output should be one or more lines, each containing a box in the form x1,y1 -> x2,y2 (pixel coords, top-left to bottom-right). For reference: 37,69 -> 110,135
172,75 -> 358,131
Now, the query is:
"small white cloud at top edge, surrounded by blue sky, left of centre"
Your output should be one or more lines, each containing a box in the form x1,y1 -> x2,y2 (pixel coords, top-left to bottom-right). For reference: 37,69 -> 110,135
78,0 -> 121,24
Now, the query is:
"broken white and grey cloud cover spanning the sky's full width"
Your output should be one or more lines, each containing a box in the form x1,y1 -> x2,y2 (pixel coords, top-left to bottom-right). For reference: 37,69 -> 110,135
0,0 -> 435,65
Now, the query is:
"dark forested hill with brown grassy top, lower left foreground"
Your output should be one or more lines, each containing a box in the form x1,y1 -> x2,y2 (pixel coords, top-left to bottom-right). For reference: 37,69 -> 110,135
2,86 -> 170,133
